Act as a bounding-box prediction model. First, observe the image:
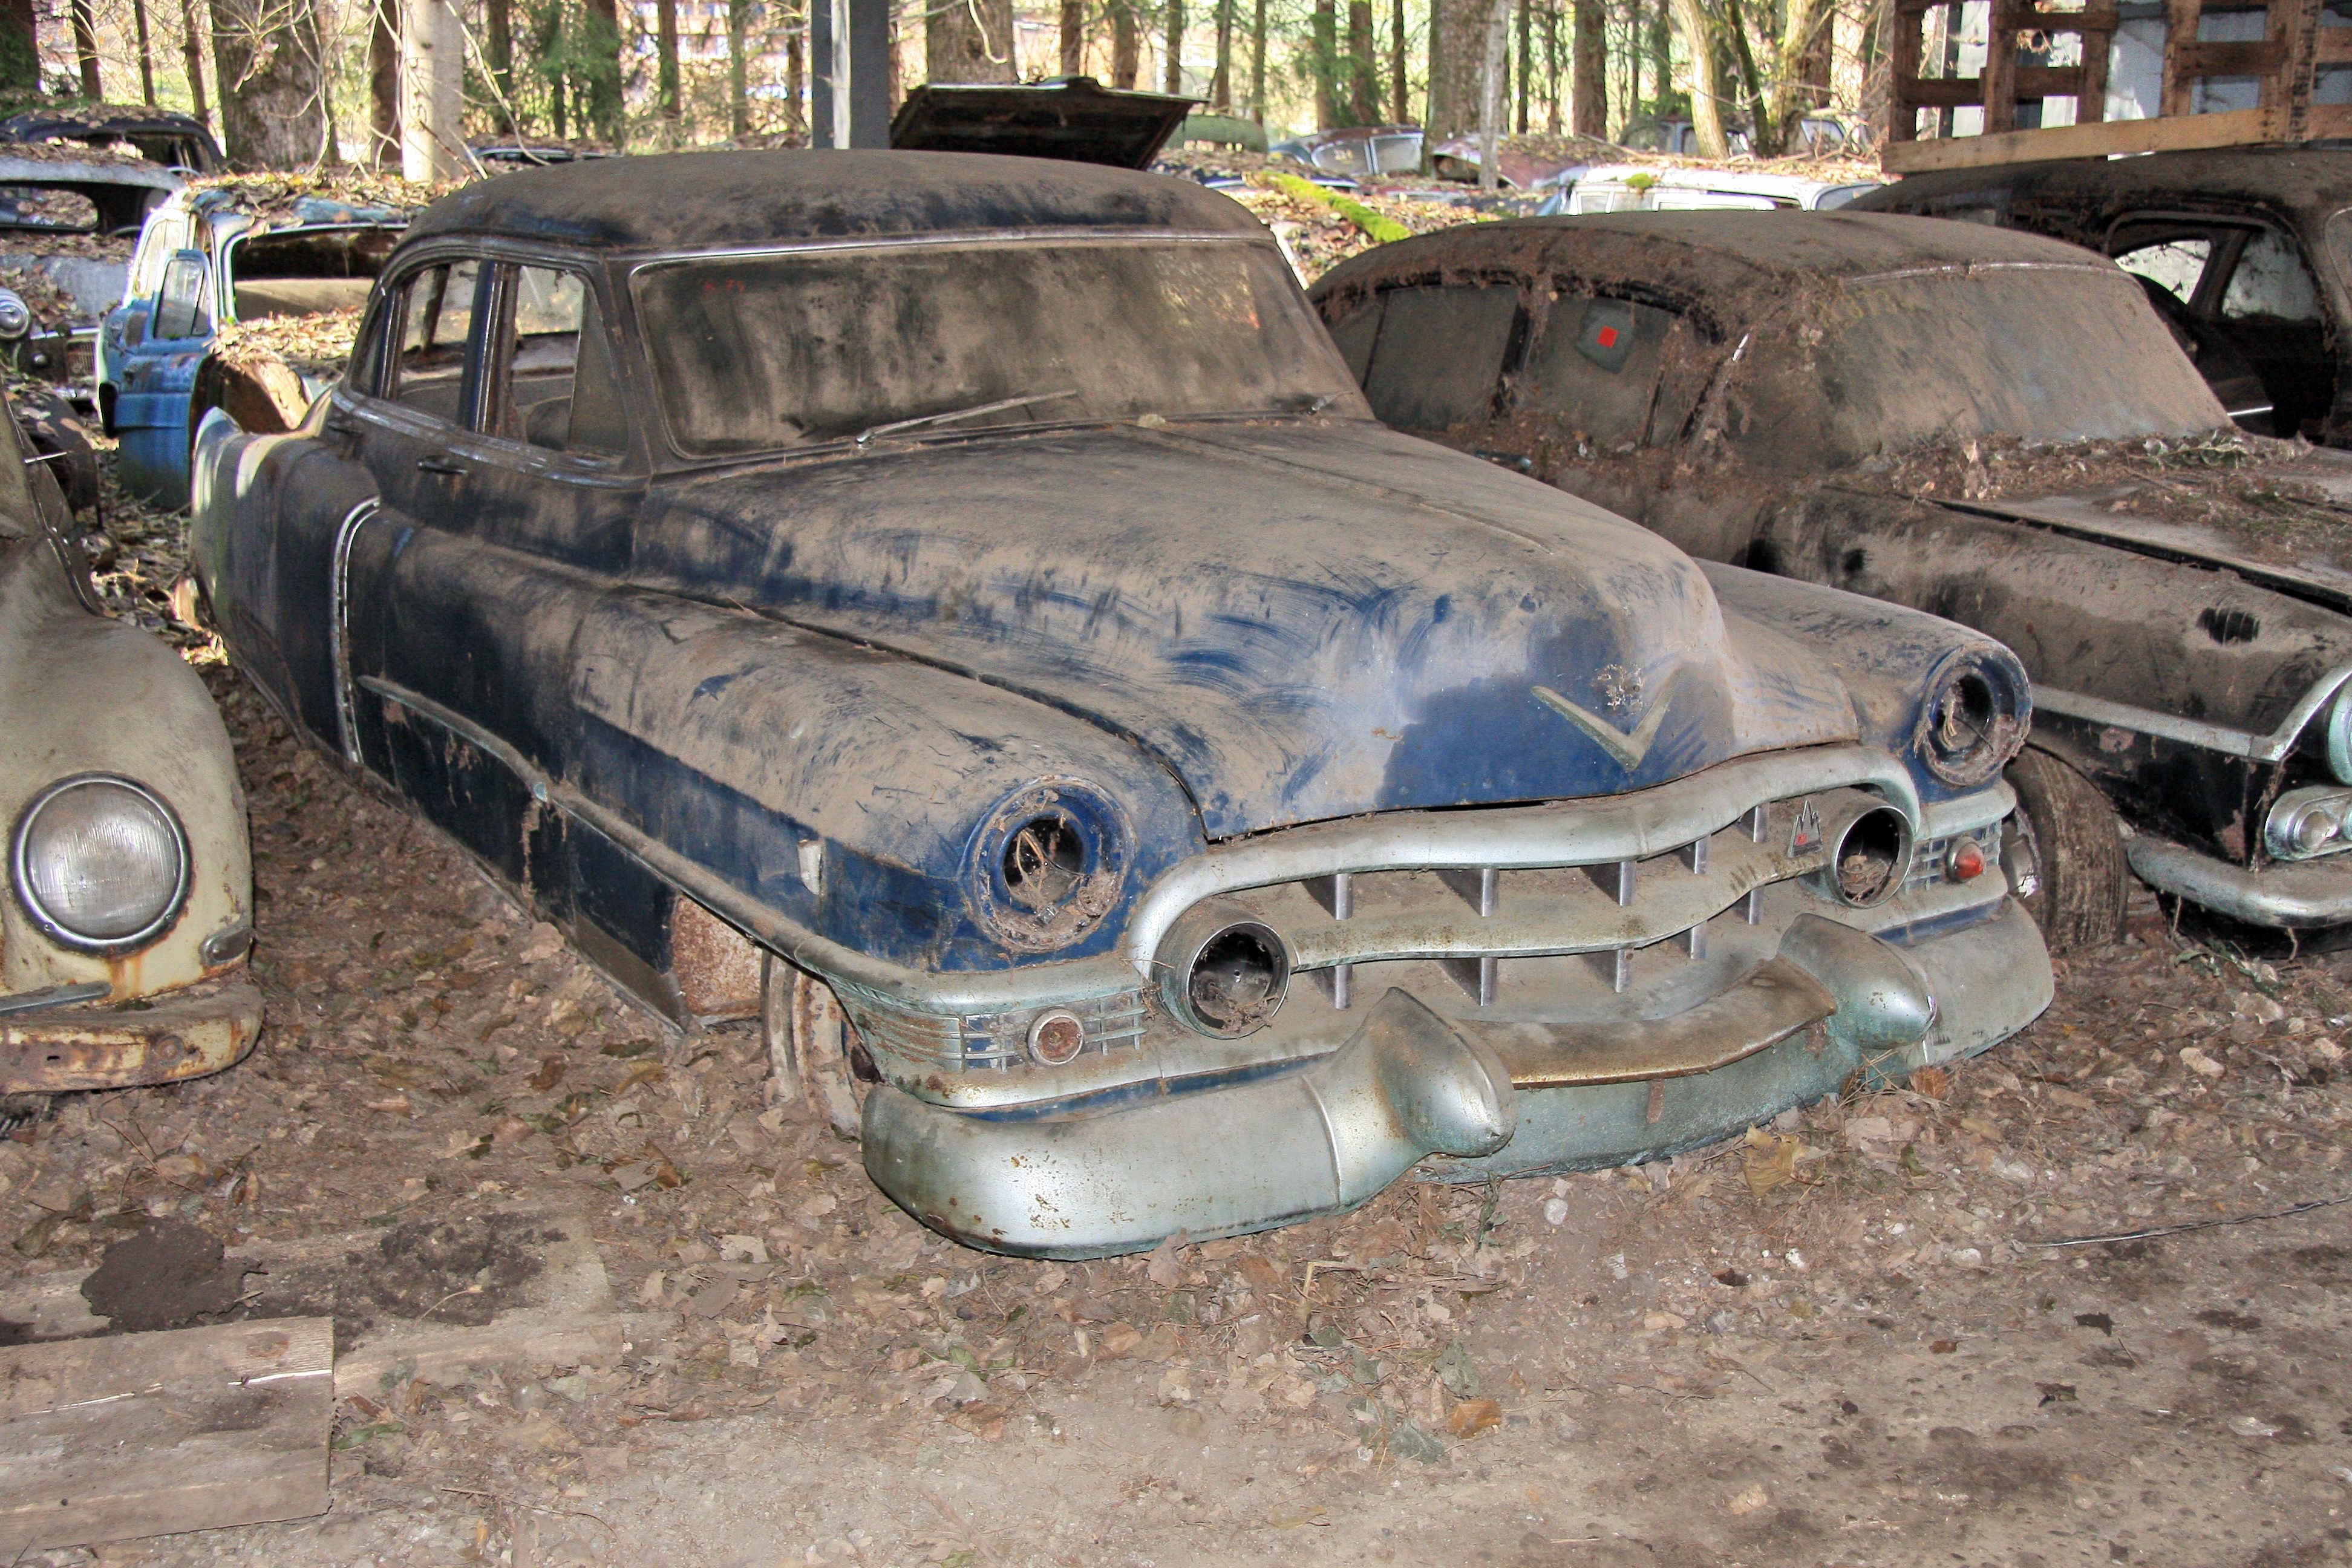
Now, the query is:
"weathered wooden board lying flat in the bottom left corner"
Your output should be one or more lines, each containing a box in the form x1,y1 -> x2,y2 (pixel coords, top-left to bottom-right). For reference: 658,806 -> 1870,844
0,1316 -> 334,1561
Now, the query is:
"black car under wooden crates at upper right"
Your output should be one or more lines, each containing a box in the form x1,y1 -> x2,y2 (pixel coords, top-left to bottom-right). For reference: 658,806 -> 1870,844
1854,146 -> 2352,446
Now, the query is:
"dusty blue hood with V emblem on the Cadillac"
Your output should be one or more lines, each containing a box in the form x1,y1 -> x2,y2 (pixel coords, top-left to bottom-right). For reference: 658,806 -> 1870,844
633,423 -> 1858,837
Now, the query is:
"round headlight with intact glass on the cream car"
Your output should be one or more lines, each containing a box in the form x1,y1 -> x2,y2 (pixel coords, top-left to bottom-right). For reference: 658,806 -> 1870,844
10,774 -> 188,952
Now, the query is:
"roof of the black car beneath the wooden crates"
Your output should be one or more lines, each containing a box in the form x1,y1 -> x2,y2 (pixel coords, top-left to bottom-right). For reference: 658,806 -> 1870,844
1858,146 -> 2352,212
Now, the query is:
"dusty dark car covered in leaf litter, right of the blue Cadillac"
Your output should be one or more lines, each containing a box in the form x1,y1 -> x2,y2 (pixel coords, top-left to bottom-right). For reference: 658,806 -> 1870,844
1315,212 -> 2352,942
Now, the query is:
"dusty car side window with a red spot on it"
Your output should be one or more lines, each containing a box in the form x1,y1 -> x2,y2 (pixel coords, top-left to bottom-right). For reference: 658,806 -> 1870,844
1517,294 -> 1708,446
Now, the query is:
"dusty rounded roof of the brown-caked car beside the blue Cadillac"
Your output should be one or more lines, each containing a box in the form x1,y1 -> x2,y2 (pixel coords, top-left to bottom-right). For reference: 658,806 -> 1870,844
1315,209 -> 2114,313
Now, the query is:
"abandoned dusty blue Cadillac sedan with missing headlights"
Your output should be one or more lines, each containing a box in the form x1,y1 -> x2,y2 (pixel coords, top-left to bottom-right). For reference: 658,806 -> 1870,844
195,153 -> 2051,1258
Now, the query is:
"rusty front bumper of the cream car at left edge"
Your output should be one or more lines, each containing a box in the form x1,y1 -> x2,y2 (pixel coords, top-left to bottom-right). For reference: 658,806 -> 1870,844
0,973 -> 261,1093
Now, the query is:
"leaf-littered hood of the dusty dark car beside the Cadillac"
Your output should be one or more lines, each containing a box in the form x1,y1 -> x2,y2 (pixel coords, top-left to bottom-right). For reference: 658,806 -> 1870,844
1915,451 -> 2352,613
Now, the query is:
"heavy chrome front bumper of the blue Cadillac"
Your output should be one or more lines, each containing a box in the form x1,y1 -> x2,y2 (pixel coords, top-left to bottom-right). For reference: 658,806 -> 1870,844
863,900 -> 2051,1258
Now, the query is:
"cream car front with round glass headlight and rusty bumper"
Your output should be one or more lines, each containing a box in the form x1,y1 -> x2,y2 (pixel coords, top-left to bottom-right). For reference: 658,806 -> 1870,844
0,390 -> 261,1096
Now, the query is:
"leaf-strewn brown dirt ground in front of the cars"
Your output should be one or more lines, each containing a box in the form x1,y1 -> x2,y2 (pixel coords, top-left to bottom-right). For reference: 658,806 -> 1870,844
13,503 -> 2352,1568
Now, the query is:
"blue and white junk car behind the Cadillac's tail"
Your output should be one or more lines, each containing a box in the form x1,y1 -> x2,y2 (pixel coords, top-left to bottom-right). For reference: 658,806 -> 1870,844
96,178 -> 410,506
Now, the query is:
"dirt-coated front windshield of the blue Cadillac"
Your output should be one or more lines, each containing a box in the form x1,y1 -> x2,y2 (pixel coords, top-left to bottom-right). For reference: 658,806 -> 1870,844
635,240 -> 1367,456
